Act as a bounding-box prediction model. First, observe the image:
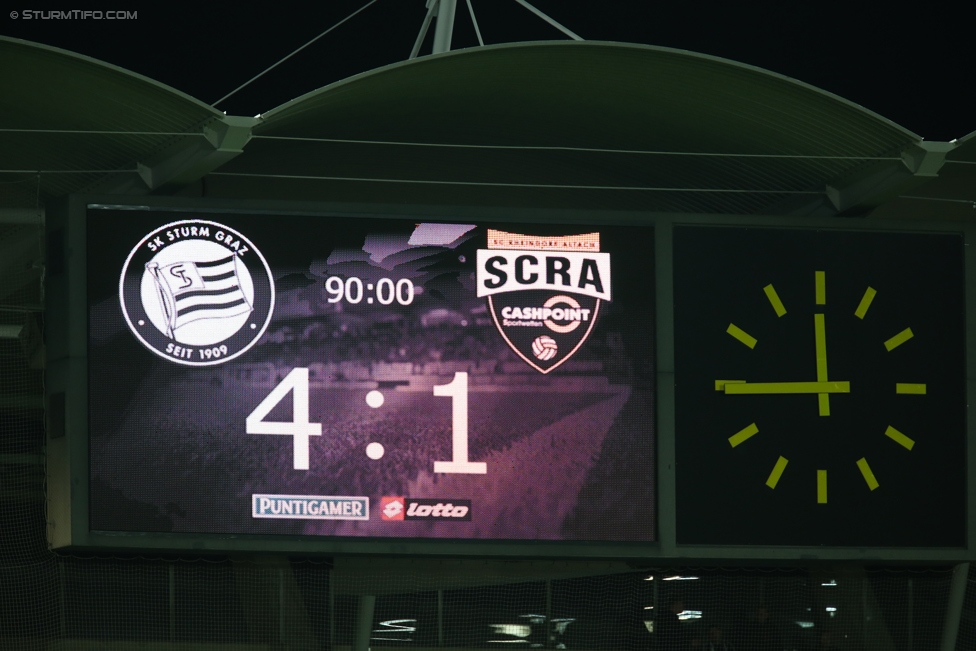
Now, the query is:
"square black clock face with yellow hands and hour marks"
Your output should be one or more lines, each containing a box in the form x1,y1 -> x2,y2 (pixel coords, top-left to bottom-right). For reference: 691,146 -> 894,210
674,227 -> 966,547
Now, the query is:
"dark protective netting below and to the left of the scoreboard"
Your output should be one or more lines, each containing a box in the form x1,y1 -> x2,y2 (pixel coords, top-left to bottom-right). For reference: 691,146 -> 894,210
0,179 -> 976,651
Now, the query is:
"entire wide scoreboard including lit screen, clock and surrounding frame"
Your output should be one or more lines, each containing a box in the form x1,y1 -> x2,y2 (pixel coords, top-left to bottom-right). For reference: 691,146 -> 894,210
47,196 -> 976,561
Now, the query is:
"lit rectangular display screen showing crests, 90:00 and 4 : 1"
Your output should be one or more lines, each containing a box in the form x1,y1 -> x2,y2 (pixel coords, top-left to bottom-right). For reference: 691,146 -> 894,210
87,208 -> 656,541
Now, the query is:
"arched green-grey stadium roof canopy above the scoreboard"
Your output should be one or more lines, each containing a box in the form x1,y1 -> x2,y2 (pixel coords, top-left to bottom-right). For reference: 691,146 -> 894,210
0,37 -> 976,219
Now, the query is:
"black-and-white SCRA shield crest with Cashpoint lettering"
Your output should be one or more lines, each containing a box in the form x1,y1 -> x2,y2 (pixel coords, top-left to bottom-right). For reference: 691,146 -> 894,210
478,229 -> 610,373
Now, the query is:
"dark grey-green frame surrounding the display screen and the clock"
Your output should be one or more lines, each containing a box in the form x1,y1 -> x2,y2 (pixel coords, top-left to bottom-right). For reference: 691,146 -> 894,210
46,195 -> 976,563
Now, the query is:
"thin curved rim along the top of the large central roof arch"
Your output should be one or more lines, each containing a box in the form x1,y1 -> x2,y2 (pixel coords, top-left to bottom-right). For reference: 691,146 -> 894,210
261,41 -> 922,141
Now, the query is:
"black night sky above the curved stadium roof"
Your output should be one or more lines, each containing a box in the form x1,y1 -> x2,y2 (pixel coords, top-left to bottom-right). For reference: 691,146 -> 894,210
0,0 -> 976,140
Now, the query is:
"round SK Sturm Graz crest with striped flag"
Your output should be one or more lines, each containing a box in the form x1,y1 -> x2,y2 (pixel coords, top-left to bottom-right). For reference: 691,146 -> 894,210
119,220 -> 274,366
